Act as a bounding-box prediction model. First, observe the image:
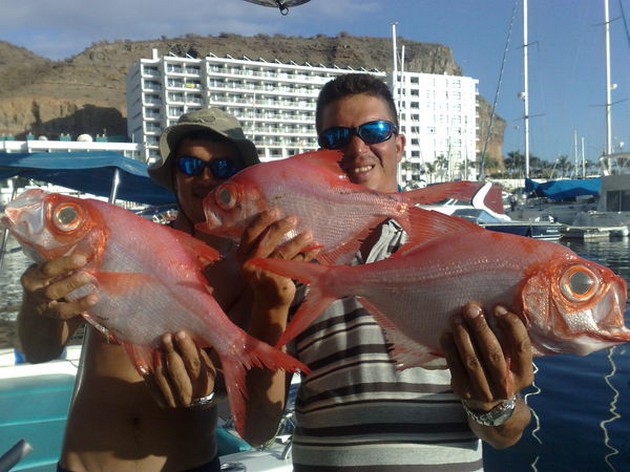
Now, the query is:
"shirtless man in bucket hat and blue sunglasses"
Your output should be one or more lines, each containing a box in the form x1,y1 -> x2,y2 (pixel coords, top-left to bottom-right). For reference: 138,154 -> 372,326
13,108 -> 310,472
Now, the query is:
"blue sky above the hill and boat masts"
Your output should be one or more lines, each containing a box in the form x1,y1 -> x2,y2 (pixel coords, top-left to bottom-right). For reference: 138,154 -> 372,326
0,0 -> 630,161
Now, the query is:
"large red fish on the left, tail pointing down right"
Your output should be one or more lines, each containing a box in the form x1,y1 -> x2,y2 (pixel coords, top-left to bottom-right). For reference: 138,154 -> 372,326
2,189 -> 308,438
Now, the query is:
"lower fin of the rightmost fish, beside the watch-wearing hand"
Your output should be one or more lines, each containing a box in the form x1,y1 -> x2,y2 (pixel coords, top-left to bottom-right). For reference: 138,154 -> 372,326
357,297 -> 446,370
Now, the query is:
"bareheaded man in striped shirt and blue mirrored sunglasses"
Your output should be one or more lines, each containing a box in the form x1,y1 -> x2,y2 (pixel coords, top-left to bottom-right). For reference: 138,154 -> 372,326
247,74 -> 533,472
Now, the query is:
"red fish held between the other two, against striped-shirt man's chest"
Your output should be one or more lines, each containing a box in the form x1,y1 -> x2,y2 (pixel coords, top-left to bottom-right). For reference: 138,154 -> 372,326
198,151 -> 492,262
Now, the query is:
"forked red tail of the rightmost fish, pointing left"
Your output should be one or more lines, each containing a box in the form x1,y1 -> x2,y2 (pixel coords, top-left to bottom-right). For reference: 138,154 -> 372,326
249,258 -> 340,347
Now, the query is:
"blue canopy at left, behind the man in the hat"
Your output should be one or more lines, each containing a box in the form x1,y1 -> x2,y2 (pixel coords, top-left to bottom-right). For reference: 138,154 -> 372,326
0,151 -> 175,205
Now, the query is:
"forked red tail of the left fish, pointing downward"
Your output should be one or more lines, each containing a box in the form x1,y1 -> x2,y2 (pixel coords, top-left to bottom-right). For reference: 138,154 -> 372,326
219,331 -> 310,436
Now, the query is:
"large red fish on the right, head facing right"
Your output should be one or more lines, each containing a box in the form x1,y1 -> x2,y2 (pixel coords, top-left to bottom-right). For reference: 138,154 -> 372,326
251,210 -> 630,368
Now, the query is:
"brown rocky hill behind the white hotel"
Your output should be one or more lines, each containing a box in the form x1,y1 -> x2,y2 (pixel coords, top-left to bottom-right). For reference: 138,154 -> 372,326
0,33 -> 505,160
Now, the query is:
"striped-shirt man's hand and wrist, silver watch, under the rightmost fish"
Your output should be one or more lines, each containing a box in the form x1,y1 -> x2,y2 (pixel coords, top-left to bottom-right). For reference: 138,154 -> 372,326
441,303 -> 534,449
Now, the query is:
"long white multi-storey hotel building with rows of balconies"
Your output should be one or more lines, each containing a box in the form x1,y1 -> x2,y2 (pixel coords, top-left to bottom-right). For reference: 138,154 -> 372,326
126,50 -> 478,186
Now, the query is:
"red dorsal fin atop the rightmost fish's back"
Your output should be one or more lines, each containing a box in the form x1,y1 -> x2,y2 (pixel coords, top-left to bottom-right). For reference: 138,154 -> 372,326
392,207 -> 487,257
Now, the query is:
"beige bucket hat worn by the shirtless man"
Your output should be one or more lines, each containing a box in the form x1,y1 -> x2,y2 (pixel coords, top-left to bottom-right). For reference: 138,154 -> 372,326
148,108 -> 260,190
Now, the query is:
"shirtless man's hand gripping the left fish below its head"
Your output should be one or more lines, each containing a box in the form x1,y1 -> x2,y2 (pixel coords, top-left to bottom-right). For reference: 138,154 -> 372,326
17,256 -> 97,362
